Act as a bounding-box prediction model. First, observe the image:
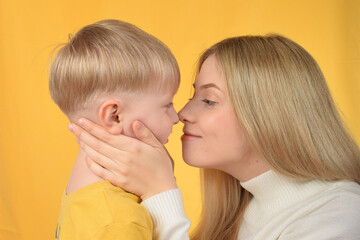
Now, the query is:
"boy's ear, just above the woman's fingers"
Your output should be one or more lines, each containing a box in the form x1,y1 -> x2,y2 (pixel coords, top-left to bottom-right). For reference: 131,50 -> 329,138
99,100 -> 124,135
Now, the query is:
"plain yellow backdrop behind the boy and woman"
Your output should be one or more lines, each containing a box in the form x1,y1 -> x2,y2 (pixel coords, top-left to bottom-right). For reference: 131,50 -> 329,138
0,0 -> 360,240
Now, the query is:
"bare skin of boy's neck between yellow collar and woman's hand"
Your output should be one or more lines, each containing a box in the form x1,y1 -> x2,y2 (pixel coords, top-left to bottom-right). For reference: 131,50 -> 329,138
66,148 -> 103,195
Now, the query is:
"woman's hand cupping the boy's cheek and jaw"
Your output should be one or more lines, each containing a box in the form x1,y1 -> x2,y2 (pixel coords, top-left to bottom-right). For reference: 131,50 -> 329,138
69,119 -> 177,200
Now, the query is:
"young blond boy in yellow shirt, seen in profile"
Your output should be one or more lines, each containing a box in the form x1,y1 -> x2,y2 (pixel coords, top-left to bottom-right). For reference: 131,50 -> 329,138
50,20 -> 180,240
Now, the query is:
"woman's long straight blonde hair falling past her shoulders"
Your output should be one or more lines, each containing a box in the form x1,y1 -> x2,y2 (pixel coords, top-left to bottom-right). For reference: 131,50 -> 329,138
192,35 -> 360,240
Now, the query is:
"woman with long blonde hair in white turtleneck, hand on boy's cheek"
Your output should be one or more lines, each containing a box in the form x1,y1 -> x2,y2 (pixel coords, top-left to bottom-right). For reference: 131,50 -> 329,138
69,35 -> 360,240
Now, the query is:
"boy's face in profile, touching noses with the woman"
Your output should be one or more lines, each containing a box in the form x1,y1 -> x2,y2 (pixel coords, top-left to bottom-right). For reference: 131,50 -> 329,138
122,90 -> 179,144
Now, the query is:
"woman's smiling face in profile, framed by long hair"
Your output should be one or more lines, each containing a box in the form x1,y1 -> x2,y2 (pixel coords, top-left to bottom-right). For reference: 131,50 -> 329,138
179,56 -> 264,181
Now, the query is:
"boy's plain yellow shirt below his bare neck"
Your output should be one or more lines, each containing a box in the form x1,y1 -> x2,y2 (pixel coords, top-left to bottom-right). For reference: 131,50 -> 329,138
55,181 -> 153,240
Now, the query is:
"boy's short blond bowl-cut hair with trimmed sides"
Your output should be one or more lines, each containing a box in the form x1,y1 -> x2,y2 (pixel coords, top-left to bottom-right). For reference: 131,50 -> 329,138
49,20 -> 180,115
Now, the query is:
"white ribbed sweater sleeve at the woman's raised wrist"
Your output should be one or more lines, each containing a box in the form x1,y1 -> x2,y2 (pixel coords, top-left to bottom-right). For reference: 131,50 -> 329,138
141,189 -> 191,240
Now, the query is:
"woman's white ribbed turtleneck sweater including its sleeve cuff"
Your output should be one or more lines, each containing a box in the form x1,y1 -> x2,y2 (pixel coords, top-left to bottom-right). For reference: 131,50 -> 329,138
142,171 -> 360,240
